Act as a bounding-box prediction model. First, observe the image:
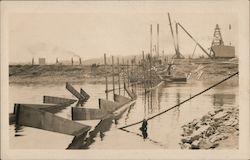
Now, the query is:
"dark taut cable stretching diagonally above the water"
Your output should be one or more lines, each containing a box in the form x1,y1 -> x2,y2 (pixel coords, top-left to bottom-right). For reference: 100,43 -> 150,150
118,72 -> 239,129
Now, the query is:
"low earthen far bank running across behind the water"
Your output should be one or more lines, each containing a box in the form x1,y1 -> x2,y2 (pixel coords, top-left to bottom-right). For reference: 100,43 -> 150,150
9,59 -> 238,86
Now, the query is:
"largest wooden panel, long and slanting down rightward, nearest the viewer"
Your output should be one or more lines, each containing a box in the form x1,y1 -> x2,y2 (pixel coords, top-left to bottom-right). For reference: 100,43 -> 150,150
15,105 -> 91,136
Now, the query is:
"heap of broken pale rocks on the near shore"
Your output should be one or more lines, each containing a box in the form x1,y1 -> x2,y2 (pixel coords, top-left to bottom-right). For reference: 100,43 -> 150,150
180,106 -> 239,149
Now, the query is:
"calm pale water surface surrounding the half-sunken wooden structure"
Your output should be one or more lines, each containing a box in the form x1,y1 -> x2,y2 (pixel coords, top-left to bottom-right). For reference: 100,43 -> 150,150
9,81 -> 238,149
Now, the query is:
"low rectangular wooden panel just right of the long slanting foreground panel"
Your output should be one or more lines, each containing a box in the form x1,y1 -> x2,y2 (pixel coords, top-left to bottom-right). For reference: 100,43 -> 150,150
71,107 -> 108,120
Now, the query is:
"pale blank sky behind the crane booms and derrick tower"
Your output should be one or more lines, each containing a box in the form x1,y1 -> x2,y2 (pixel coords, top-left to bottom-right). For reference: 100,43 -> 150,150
8,2 -> 238,63
